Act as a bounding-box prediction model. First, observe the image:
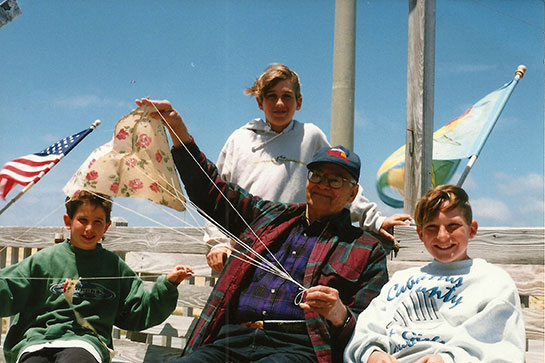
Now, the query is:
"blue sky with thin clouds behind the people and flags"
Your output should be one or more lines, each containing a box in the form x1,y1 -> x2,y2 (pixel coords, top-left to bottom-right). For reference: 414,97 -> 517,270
0,0 -> 544,226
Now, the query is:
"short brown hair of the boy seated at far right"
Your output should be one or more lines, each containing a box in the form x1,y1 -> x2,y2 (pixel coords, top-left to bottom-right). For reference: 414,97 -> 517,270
414,184 -> 473,227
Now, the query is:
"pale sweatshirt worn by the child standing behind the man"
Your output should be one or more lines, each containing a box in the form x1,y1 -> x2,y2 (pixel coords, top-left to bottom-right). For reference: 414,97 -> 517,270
204,119 -> 386,246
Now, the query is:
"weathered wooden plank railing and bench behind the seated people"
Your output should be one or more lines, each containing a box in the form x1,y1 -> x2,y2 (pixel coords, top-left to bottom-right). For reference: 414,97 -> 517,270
0,227 -> 545,363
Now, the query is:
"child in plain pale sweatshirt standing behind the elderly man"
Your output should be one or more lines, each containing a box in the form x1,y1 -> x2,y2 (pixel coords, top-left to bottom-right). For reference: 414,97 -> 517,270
204,63 -> 410,272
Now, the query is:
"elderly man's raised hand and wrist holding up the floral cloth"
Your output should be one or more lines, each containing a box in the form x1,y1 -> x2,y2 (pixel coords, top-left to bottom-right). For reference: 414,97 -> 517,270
135,98 -> 191,147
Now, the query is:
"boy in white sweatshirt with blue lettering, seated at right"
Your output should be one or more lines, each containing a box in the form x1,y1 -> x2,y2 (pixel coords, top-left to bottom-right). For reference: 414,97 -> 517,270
344,185 -> 525,363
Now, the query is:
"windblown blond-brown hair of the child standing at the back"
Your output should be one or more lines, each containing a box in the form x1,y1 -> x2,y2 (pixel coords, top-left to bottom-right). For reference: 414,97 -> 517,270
244,63 -> 303,101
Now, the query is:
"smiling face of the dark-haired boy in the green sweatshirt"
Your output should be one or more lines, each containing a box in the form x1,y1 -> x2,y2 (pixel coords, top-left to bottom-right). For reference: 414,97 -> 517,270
64,201 -> 111,250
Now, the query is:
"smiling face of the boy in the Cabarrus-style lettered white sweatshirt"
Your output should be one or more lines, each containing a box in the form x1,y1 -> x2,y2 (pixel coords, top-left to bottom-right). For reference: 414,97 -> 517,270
416,207 -> 478,263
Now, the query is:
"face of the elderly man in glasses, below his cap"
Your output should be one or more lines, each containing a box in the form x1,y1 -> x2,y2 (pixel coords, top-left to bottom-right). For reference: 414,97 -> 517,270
306,163 -> 358,222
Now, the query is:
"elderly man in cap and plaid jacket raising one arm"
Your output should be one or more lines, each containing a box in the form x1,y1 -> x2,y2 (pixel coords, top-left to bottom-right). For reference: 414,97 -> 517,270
137,99 -> 388,363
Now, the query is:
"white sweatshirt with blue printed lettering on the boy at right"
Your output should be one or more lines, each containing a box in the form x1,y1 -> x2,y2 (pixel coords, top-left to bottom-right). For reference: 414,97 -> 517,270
344,259 -> 525,363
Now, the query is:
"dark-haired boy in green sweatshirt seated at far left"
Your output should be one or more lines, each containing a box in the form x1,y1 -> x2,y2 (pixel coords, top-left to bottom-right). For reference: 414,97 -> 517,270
0,191 -> 193,363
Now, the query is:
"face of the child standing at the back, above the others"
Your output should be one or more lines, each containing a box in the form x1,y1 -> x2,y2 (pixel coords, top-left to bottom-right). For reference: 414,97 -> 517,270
257,79 -> 303,132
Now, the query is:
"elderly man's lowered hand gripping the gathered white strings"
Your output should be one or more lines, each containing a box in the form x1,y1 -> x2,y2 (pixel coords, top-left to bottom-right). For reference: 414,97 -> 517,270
299,285 -> 344,327
